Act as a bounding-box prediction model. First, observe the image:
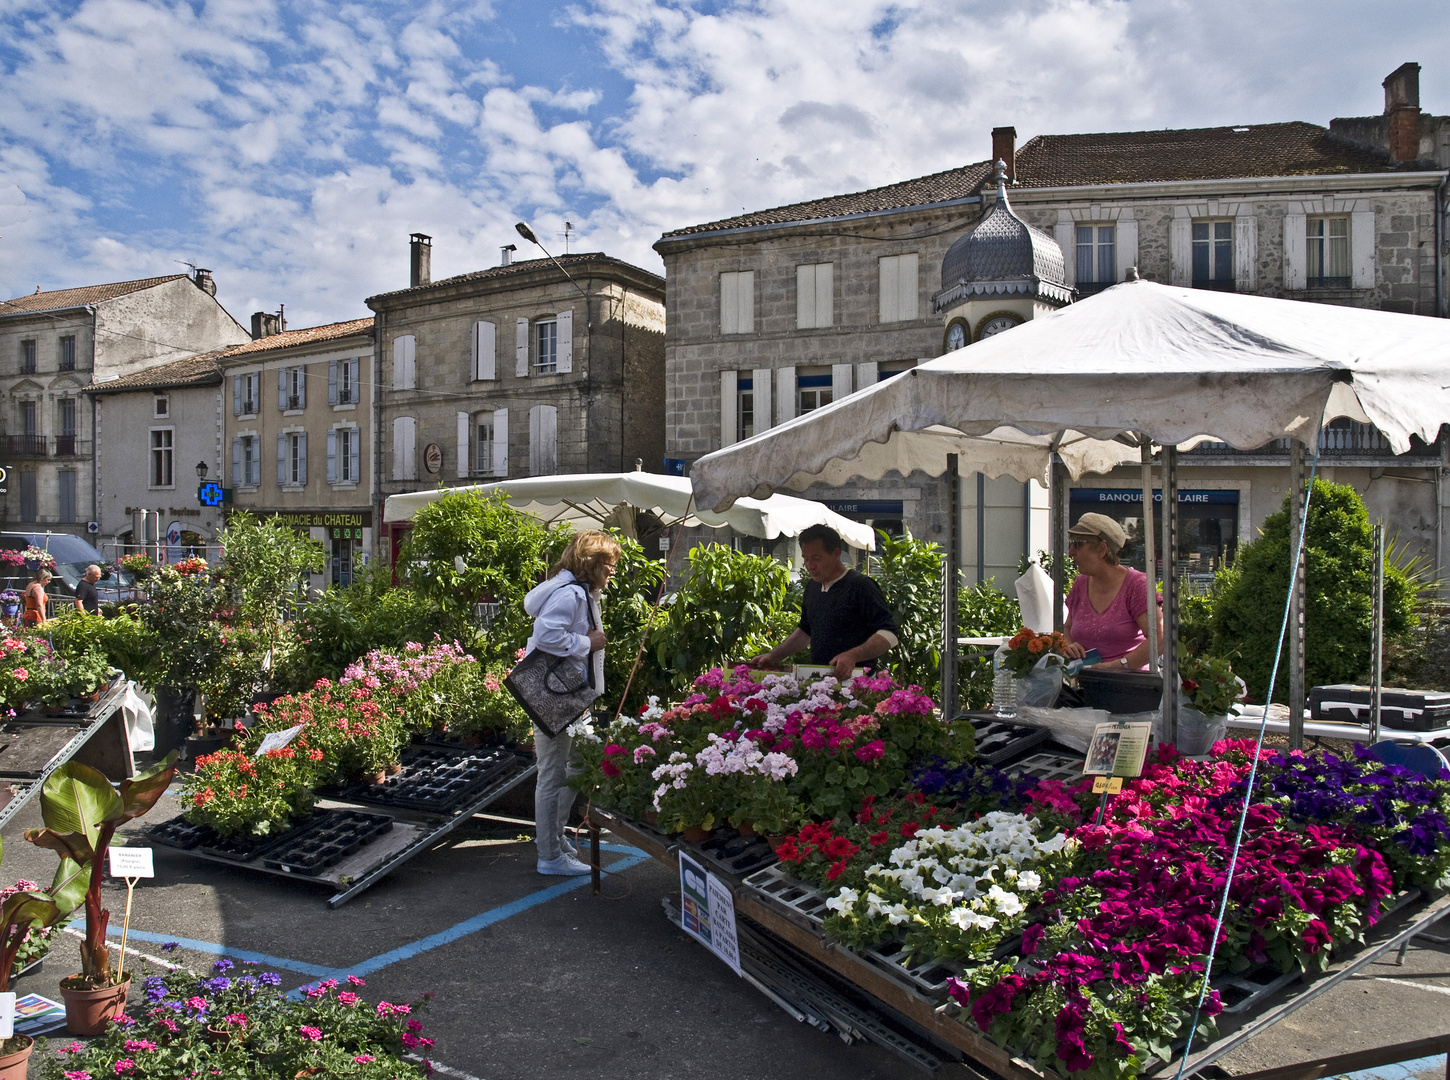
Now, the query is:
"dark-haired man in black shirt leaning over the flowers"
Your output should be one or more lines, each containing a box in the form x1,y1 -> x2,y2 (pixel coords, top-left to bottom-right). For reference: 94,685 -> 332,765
748,525 -> 898,678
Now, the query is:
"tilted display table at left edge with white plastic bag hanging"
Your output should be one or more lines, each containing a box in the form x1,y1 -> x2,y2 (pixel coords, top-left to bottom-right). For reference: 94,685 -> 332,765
0,680 -> 136,828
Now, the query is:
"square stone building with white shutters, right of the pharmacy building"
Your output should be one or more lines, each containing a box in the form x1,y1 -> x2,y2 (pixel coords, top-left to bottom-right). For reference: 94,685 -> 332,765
367,236 -> 666,557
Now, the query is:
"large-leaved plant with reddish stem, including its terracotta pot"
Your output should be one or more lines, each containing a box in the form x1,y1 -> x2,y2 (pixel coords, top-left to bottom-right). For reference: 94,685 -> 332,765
25,754 -> 177,1035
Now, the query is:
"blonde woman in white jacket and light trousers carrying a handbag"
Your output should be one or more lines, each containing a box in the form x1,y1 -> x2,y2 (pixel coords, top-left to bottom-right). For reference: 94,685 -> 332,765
523,532 -> 619,877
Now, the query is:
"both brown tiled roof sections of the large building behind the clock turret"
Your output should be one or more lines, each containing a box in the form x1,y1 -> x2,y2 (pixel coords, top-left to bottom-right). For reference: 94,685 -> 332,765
661,120 -> 1430,241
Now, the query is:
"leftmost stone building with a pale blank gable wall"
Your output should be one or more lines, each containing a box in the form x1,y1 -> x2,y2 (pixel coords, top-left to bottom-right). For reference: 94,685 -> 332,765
0,270 -> 248,535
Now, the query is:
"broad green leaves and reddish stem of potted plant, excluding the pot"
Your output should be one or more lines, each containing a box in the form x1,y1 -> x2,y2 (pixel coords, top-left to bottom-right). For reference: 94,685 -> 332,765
25,752 -> 177,990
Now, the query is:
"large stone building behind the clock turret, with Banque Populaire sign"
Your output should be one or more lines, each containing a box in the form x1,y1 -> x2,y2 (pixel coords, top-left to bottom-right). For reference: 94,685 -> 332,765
655,65 -> 1450,583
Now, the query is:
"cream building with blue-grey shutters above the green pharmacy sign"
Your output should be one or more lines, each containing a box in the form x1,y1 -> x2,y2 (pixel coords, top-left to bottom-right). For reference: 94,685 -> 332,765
212,316 -> 377,587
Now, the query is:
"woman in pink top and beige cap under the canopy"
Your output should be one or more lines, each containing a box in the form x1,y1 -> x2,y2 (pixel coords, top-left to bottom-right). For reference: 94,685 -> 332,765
1063,513 -> 1163,671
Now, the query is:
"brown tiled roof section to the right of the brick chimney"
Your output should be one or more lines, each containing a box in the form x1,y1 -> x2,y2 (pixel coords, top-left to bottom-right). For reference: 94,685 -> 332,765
1015,120 -> 1393,187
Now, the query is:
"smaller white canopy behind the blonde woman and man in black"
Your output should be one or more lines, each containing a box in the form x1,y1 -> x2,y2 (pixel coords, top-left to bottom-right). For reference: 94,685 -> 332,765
383,473 -> 876,551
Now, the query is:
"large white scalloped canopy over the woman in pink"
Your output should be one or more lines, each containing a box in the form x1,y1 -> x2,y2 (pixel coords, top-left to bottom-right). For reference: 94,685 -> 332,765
690,281 -> 1450,510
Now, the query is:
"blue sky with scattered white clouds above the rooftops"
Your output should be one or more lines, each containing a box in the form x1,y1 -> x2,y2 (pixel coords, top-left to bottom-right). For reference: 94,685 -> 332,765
0,0 -> 1450,326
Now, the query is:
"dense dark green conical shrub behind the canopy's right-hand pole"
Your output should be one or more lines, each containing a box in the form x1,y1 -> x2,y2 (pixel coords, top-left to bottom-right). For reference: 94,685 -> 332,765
1212,480 -> 1418,702
